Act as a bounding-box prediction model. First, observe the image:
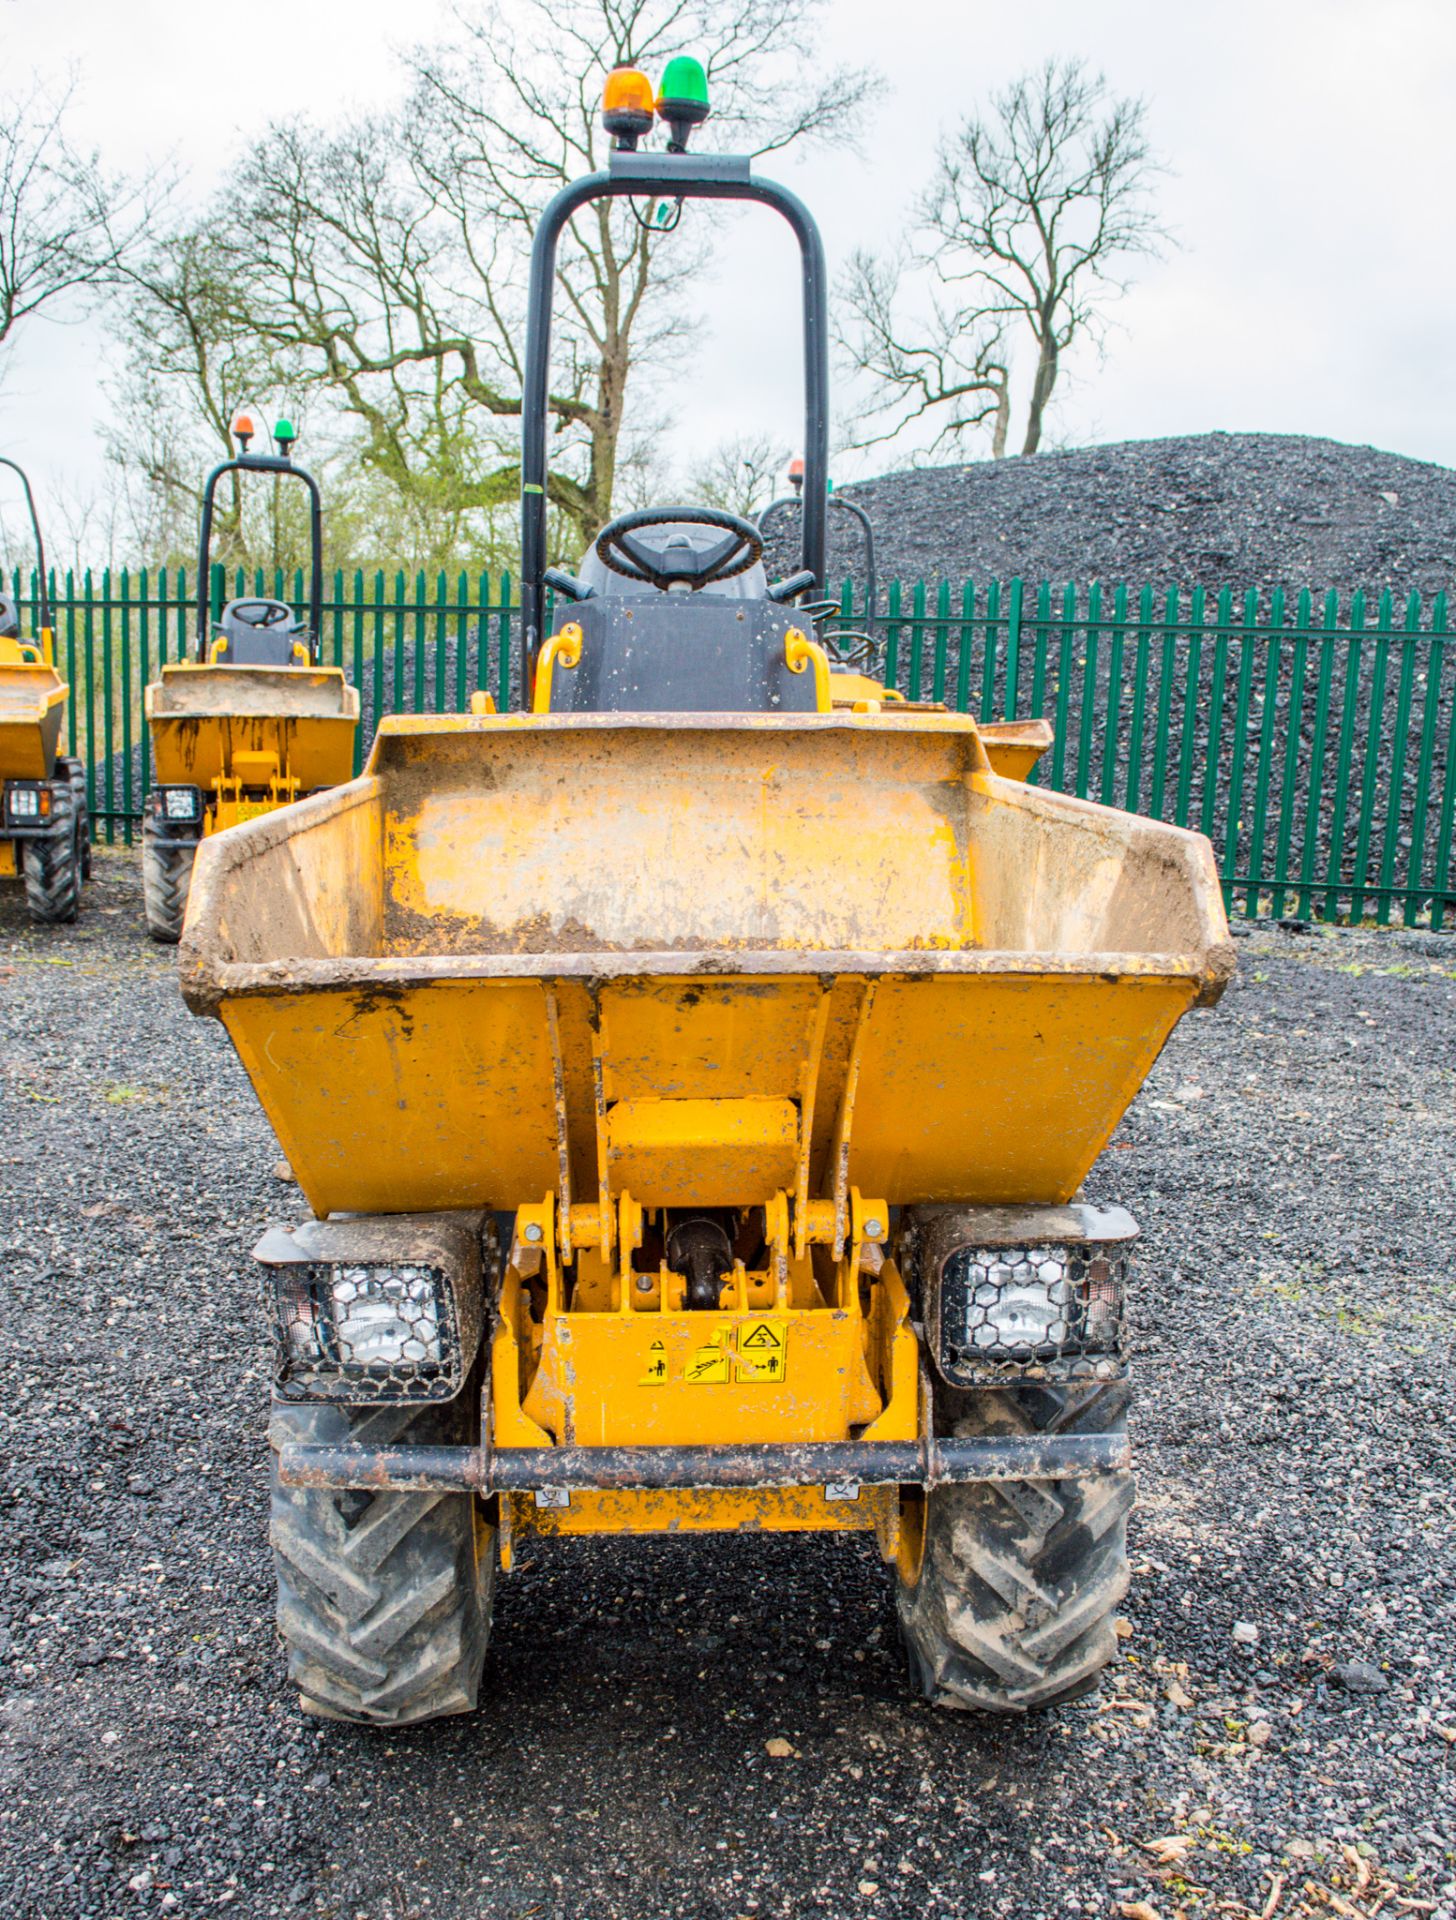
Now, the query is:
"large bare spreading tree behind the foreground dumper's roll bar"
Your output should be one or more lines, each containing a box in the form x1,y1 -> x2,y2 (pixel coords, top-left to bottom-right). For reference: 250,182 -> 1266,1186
202,0 -> 866,543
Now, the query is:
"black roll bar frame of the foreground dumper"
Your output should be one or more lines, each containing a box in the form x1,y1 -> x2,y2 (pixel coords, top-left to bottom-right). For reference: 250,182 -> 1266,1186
521,150 -> 830,691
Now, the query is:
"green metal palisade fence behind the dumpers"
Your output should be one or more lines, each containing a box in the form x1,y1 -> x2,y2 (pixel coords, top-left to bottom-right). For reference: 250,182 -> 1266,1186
13,568 -> 1456,927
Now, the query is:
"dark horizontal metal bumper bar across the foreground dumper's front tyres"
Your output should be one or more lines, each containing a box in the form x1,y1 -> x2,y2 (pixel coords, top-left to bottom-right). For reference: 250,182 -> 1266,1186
279,1434 -> 1131,1494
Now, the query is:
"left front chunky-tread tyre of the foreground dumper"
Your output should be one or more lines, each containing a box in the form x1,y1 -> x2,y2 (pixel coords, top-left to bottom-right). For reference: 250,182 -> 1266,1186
269,1388 -> 496,1726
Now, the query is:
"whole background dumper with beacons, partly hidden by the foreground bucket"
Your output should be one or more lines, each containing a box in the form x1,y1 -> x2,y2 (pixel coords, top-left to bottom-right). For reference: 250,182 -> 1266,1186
142,430 -> 359,943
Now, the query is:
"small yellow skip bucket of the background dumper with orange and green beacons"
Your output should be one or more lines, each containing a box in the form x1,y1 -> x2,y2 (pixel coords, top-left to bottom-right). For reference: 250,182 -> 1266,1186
146,662 -> 359,793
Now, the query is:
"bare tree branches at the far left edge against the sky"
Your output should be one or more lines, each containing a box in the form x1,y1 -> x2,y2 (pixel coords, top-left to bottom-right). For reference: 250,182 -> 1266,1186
0,81 -> 150,360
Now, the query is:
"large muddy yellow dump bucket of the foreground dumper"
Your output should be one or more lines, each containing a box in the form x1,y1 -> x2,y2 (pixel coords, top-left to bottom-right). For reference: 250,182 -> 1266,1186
182,714 -> 1233,1213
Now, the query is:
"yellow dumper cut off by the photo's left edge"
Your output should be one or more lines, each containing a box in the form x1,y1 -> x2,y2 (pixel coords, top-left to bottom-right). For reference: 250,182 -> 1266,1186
0,457 -> 90,925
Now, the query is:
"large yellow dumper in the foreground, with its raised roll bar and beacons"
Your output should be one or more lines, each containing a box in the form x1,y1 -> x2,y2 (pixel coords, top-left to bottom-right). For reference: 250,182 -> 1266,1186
182,61 -> 1231,1726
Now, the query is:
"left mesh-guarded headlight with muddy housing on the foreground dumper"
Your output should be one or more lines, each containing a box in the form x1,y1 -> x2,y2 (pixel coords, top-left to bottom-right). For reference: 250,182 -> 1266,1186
257,1213 -> 482,1402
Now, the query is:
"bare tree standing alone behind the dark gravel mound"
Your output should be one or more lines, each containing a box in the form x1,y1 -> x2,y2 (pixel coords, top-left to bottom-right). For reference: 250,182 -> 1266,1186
841,60 -> 1168,457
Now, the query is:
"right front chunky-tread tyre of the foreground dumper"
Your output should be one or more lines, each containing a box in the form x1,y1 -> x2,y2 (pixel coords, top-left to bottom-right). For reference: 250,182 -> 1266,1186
899,1380 -> 1133,1713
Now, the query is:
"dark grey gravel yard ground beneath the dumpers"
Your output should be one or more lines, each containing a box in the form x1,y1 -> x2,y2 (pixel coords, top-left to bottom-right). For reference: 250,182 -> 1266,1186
0,852 -> 1456,1920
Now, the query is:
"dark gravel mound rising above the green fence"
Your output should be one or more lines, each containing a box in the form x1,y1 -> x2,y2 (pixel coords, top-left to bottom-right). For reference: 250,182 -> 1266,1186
774,434 -> 1456,601
